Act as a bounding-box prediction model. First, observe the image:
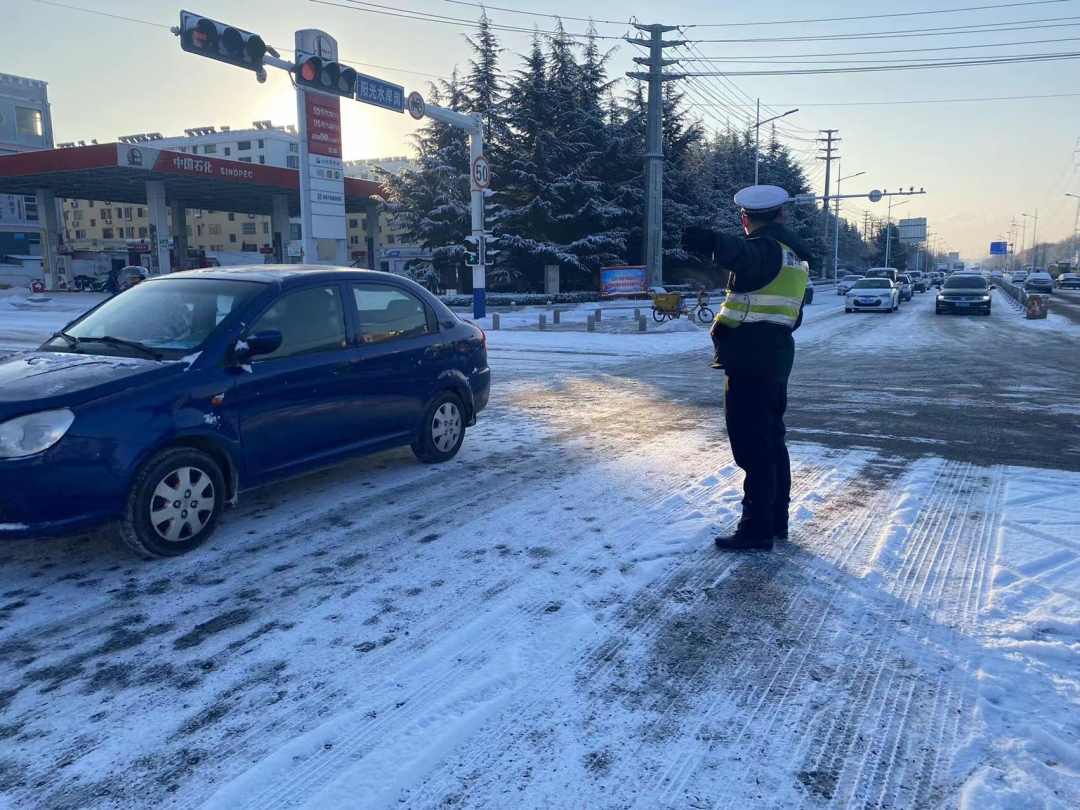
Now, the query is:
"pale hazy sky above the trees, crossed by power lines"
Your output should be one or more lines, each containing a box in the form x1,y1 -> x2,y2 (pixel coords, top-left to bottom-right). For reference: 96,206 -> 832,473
12,0 -> 1080,260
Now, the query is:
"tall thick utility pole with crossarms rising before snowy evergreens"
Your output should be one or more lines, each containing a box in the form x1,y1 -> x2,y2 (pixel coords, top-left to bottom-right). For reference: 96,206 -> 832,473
626,23 -> 686,287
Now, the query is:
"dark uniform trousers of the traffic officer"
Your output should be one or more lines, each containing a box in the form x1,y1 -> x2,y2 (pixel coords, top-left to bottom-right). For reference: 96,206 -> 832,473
724,369 -> 792,538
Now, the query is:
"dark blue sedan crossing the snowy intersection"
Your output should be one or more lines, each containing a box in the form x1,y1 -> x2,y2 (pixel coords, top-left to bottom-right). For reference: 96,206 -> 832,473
0,265 -> 490,557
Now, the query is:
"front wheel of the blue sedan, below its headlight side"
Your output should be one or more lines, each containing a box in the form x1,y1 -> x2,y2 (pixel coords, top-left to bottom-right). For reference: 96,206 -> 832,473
120,447 -> 226,557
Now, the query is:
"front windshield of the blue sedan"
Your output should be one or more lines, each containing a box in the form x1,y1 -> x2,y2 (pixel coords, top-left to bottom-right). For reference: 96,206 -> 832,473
46,278 -> 266,357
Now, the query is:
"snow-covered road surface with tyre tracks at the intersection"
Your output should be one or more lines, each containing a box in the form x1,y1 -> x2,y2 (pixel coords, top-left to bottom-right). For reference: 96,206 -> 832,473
0,296 -> 1080,810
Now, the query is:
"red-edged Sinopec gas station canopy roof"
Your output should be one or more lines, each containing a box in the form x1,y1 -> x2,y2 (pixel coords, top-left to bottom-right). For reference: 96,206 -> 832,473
0,144 -> 381,216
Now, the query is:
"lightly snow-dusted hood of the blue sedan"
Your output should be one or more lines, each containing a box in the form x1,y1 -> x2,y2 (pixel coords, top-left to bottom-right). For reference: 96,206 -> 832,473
0,352 -> 187,419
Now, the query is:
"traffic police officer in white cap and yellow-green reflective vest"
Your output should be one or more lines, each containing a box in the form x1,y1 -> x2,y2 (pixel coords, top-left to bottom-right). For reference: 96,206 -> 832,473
683,186 -> 810,551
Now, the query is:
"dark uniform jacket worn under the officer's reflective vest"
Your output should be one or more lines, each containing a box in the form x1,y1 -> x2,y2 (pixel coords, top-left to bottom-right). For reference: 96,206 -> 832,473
713,222 -> 810,380
